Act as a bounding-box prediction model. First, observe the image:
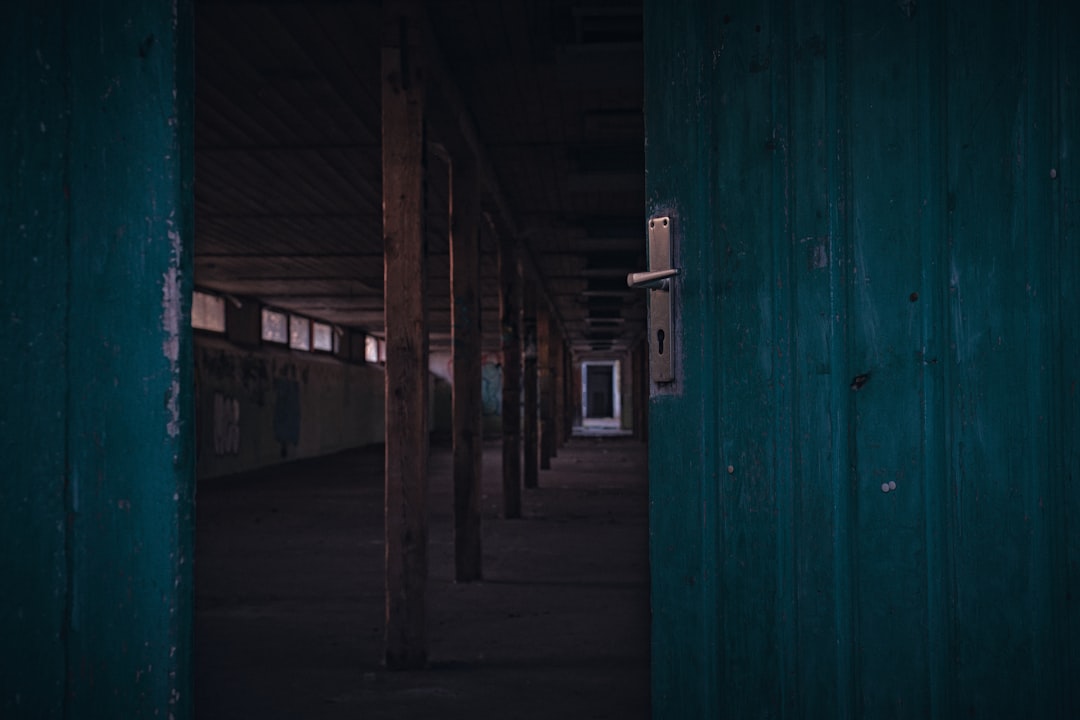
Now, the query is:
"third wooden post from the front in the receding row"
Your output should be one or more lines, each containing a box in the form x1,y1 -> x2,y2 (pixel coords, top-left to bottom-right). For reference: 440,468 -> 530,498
499,237 -> 522,518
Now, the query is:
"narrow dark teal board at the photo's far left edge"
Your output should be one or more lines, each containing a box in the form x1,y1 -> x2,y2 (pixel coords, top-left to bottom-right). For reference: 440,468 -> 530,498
0,1 -> 70,717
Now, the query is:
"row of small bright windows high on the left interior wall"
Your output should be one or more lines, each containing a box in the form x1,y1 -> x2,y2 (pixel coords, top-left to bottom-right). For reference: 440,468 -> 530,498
191,290 -> 387,363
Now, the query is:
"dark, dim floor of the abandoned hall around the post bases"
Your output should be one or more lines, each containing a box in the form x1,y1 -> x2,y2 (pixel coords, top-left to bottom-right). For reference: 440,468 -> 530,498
194,437 -> 649,720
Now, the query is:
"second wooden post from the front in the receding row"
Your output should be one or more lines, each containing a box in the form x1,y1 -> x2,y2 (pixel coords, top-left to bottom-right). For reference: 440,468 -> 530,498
450,160 -> 484,583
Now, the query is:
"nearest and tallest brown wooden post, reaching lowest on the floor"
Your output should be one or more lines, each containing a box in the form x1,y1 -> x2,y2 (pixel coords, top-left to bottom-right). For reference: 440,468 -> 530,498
382,0 -> 428,669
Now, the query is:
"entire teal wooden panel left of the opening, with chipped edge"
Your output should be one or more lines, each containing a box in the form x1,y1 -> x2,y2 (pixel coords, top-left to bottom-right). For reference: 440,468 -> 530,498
0,0 -> 194,718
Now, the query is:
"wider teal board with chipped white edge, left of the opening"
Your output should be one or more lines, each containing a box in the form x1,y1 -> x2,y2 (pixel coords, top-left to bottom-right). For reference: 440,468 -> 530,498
67,0 -> 194,717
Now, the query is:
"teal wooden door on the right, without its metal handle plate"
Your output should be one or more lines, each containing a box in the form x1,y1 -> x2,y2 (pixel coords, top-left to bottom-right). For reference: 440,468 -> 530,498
645,0 -> 1080,719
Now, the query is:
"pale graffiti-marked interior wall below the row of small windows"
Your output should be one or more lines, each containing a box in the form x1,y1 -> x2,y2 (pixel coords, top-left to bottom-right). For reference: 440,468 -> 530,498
194,335 -> 386,478
